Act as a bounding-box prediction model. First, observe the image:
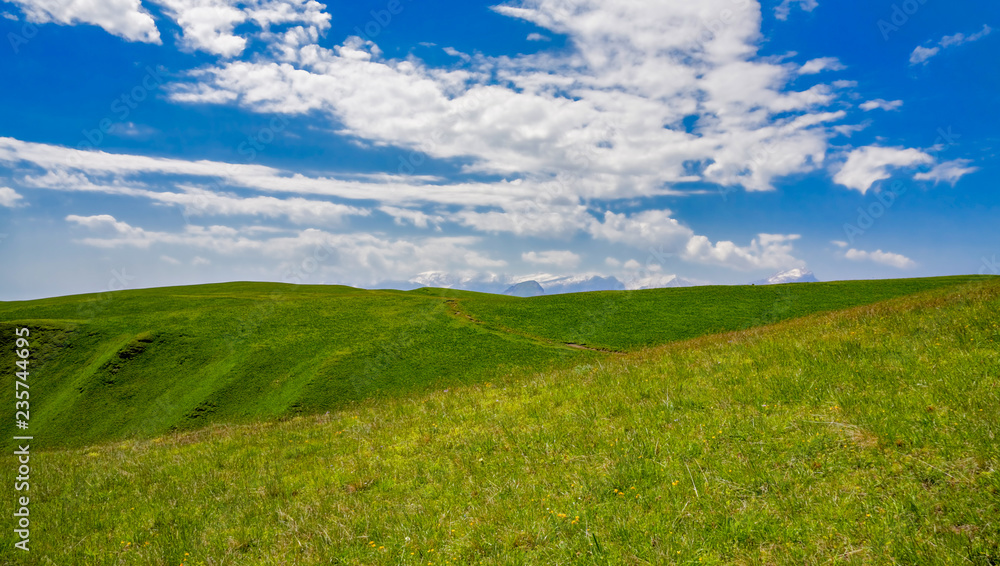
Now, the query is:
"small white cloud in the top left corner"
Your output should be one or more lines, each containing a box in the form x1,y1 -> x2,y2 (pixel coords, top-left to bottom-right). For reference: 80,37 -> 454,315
10,0 -> 160,44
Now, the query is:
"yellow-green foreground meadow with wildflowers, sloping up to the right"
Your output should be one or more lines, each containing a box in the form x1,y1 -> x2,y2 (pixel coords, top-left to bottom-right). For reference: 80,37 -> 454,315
0,279 -> 1000,566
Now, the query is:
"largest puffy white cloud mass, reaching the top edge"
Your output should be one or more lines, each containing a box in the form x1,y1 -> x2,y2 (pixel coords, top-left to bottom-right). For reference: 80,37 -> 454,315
171,0 -> 843,198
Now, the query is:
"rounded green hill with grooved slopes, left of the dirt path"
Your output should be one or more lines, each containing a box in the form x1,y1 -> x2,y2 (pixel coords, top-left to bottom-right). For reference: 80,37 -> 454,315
0,283 -> 590,445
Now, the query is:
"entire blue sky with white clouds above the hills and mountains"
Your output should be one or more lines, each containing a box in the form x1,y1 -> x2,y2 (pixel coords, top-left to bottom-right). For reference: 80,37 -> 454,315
0,0 -> 1000,300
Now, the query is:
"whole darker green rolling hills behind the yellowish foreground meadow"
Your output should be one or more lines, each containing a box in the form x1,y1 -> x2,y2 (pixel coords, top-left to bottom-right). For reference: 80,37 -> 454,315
0,277 -> 988,447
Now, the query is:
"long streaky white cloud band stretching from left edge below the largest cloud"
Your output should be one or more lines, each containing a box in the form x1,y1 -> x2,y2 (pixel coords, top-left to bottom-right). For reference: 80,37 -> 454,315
15,130 -> 808,269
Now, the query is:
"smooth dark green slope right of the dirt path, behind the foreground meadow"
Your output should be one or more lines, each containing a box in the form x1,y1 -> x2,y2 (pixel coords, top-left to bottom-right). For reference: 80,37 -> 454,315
462,276 -> 983,351
